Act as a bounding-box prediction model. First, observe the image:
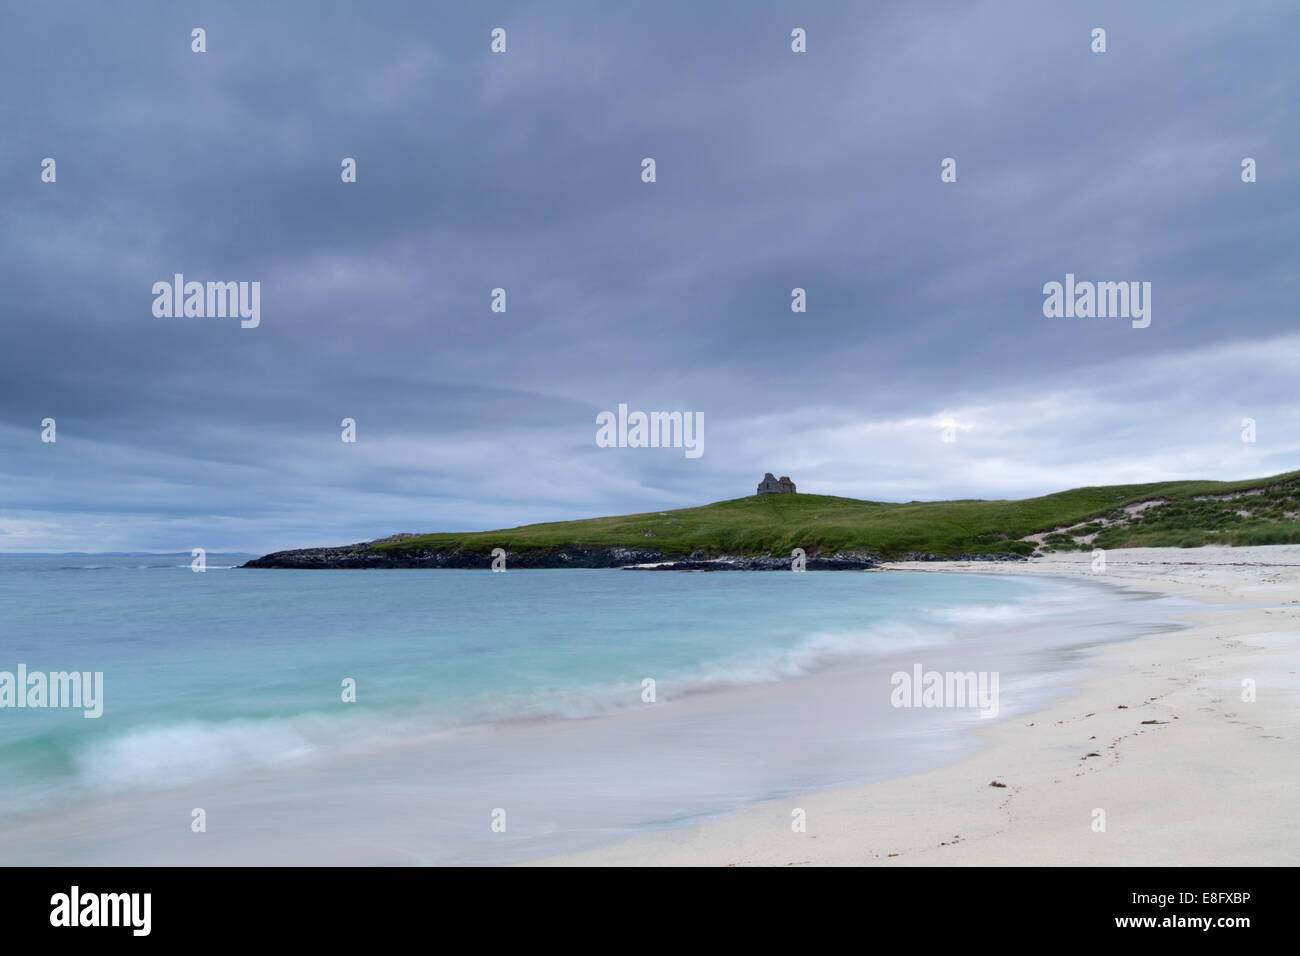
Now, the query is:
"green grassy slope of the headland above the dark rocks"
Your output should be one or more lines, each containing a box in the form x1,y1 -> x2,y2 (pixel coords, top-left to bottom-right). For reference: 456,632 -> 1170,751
371,472 -> 1300,558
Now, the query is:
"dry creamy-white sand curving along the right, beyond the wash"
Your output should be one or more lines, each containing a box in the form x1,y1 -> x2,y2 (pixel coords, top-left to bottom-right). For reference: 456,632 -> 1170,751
545,545 -> 1300,866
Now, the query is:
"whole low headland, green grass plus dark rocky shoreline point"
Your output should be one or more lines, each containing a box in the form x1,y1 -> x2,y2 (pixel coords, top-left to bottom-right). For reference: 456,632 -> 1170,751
244,471 -> 1300,570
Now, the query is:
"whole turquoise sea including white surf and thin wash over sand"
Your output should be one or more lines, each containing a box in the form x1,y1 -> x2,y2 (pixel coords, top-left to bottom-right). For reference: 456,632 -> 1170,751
0,554 -> 1182,865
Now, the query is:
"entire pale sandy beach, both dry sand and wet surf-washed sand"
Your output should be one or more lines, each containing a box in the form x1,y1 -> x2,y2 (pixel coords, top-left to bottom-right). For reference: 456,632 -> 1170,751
0,546 -> 1300,865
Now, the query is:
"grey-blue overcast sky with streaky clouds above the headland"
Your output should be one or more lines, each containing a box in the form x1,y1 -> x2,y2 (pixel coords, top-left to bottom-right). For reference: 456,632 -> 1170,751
0,0 -> 1300,553
